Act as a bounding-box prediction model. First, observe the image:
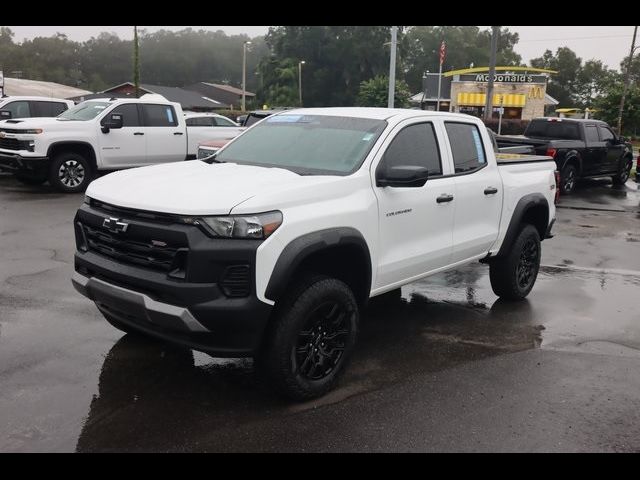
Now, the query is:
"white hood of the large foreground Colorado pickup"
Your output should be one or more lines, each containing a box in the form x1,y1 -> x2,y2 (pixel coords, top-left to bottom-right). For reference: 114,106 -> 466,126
87,160 -> 344,215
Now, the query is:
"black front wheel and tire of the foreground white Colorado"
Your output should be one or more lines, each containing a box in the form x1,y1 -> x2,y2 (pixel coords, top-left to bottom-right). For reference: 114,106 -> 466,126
258,275 -> 359,401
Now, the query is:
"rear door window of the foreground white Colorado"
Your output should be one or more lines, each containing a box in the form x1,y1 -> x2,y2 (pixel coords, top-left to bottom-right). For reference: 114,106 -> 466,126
444,122 -> 487,173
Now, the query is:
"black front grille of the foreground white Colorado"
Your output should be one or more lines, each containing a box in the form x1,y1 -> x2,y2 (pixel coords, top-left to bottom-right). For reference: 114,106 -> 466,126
83,225 -> 188,277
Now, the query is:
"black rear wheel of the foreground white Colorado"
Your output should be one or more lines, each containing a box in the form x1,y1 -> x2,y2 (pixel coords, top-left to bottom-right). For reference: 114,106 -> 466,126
489,224 -> 541,300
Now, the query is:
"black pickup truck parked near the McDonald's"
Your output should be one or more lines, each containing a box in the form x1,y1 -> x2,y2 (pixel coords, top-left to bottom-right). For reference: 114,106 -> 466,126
496,118 -> 633,194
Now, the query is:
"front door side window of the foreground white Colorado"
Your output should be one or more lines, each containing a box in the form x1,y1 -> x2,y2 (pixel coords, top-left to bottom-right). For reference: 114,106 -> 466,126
380,123 -> 442,176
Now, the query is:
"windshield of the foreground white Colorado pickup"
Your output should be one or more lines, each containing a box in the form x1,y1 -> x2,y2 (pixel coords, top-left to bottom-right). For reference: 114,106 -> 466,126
216,113 -> 387,175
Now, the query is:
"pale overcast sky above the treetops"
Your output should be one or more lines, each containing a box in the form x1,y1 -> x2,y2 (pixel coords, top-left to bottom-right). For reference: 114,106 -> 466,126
9,25 -> 640,68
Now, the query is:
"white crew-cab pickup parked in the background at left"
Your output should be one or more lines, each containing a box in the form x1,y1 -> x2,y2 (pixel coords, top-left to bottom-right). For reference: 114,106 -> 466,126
0,95 -> 241,193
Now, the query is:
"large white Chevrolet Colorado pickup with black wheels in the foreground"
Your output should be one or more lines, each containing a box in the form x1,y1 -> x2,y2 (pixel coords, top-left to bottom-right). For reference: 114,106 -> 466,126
72,108 -> 556,399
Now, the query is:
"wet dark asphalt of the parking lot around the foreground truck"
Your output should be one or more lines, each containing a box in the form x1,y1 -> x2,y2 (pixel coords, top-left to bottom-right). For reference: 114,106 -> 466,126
0,175 -> 640,452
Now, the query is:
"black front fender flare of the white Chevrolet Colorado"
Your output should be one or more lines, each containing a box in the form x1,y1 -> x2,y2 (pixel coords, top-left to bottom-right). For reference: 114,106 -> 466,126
265,227 -> 372,301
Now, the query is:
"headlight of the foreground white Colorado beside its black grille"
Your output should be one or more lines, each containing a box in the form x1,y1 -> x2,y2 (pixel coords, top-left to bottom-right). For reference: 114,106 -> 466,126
183,211 -> 282,239
